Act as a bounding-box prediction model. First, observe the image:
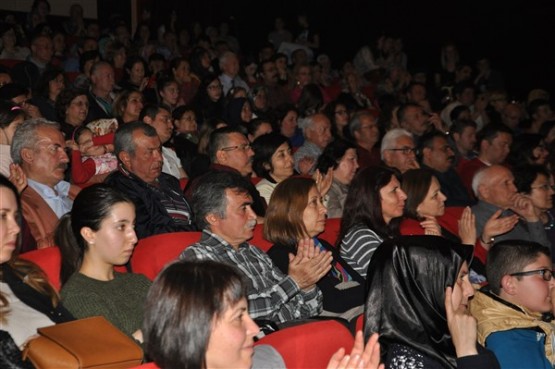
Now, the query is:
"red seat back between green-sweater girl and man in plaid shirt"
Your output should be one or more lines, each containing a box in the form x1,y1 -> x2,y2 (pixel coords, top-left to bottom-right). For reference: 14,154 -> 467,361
131,232 -> 201,280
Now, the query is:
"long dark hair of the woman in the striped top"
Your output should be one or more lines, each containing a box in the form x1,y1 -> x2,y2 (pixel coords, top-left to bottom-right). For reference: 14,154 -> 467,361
337,166 -> 401,244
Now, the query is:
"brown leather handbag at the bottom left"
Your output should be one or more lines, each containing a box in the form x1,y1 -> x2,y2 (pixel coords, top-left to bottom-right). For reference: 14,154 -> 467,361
23,316 -> 143,369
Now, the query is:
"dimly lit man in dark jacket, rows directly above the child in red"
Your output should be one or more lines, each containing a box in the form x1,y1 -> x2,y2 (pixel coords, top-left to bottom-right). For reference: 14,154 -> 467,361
85,61 -> 115,122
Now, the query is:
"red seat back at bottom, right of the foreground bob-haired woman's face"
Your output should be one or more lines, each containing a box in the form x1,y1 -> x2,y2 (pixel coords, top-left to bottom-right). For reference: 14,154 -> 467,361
255,320 -> 354,368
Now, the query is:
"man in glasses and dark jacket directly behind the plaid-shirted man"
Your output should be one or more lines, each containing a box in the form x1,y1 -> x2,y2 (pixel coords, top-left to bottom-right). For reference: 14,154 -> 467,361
185,127 -> 267,217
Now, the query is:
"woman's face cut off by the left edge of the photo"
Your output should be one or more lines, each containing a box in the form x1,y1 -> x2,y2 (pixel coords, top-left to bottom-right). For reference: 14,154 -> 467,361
0,187 -> 20,264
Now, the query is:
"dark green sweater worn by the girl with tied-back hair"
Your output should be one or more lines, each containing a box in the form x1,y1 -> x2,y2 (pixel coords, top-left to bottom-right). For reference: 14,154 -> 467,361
61,273 -> 151,336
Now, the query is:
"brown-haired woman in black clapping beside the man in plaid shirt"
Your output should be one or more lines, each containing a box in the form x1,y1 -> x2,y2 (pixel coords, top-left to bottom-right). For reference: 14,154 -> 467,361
264,177 -> 364,321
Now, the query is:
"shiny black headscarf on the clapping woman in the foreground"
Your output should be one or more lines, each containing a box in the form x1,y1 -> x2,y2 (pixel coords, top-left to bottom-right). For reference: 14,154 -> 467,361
364,236 -> 473,368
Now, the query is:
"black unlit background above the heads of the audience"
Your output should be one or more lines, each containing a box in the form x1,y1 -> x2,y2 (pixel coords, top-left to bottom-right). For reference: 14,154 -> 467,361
141,0 -> 555,99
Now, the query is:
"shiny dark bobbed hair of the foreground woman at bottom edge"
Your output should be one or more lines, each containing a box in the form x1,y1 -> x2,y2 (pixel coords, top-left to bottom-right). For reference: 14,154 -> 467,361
143,260 -> 247,369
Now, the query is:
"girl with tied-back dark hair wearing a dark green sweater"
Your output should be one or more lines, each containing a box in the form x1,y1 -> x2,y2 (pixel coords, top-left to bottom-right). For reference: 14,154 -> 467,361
56,183 -> 151,342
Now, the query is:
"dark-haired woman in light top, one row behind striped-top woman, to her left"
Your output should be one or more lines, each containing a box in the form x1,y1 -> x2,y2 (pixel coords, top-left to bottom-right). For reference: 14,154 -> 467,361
316,139 -> 358,218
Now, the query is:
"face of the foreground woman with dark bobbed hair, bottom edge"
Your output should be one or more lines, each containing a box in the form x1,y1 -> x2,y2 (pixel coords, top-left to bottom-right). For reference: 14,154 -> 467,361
206,298 -> 260,369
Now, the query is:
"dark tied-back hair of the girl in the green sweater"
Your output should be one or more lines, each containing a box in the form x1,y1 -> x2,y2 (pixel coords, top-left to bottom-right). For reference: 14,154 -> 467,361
55,183 -> 132,284
